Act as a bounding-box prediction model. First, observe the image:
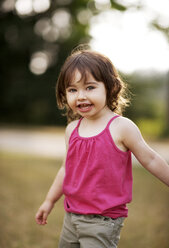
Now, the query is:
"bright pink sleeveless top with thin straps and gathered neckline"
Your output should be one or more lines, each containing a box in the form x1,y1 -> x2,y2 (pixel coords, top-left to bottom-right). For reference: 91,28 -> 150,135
63,115 -> 132,218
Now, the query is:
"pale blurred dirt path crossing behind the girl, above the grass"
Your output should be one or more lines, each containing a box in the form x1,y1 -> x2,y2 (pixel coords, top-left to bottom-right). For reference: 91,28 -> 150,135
0,128 -> 169,162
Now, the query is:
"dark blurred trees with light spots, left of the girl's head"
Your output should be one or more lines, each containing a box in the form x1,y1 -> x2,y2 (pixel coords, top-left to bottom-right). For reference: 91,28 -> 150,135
0,0 -> 126,125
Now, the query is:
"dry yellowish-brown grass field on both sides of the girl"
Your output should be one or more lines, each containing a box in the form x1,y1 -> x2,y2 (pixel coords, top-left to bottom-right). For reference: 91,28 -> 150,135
0,151 -> 169,248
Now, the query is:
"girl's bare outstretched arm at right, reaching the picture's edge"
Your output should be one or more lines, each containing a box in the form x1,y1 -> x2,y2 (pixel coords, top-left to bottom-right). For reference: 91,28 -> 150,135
122,120 -> 169,186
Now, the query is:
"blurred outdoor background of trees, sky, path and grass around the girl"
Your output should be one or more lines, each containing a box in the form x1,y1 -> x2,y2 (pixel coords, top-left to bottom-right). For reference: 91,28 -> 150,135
0,0 -> 169,248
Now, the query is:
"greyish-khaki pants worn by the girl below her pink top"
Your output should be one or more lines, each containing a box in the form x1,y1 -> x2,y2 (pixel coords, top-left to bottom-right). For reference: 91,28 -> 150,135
59,213 -> 125,248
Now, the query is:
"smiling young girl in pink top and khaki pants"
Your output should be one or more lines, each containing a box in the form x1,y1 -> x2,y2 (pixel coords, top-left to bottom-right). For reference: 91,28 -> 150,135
36,47 -> 169,248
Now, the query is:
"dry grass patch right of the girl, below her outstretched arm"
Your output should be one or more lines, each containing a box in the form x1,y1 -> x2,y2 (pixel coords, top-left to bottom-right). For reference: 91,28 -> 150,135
119,167 -> 169,248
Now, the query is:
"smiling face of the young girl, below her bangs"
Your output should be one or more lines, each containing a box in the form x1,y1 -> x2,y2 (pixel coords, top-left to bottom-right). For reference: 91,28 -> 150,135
66,70 -> 107,119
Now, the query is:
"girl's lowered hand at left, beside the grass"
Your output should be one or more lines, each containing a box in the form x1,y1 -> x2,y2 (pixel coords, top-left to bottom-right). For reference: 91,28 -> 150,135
35,200 -> 54,225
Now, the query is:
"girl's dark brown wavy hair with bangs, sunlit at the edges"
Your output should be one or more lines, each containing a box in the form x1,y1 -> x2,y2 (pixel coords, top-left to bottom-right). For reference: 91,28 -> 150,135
56,46 -> 129,121
